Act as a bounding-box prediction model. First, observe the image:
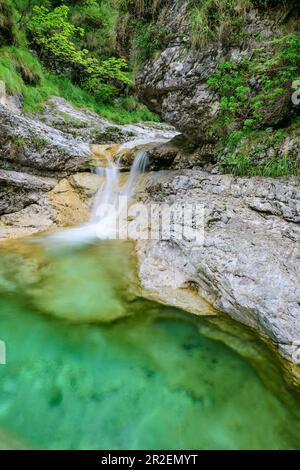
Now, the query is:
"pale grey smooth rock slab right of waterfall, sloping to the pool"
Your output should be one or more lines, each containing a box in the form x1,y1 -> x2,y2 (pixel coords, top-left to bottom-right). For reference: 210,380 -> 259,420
138,170 -> 300,368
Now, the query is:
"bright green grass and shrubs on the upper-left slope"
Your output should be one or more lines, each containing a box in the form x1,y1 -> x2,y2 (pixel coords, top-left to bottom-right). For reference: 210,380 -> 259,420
0,0 -> 158,123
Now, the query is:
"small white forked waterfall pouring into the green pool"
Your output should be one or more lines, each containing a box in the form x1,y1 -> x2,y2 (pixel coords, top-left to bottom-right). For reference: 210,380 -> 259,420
47,150 -> 148,246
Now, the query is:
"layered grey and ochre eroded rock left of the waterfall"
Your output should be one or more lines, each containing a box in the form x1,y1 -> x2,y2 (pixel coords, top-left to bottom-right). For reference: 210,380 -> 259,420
0,97 -> 176,239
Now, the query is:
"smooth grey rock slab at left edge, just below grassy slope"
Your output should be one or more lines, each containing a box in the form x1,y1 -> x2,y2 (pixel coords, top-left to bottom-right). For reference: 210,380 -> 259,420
0,105 -> 90,175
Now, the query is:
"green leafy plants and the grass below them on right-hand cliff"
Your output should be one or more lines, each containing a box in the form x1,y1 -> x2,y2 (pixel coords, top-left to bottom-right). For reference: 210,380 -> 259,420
208,34 -> 300,176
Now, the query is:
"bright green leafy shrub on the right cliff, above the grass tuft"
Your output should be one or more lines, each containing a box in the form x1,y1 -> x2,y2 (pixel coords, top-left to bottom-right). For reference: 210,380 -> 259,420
208,34 -> 300,135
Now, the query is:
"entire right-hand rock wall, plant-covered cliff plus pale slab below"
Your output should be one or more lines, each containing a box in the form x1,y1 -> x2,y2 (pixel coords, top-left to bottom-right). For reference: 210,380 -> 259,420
129,1 -> 300,374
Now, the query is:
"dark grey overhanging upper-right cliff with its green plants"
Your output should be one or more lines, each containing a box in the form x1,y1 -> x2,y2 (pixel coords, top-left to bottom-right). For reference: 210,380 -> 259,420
136,0 -> 300,174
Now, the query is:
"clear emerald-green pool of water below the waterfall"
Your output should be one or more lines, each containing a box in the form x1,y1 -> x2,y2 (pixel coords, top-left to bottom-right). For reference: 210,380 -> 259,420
0,244 -> 300,449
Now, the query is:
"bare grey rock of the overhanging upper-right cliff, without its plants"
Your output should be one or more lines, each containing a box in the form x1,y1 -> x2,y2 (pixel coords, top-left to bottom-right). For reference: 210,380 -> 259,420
135,0 -> 297,143
